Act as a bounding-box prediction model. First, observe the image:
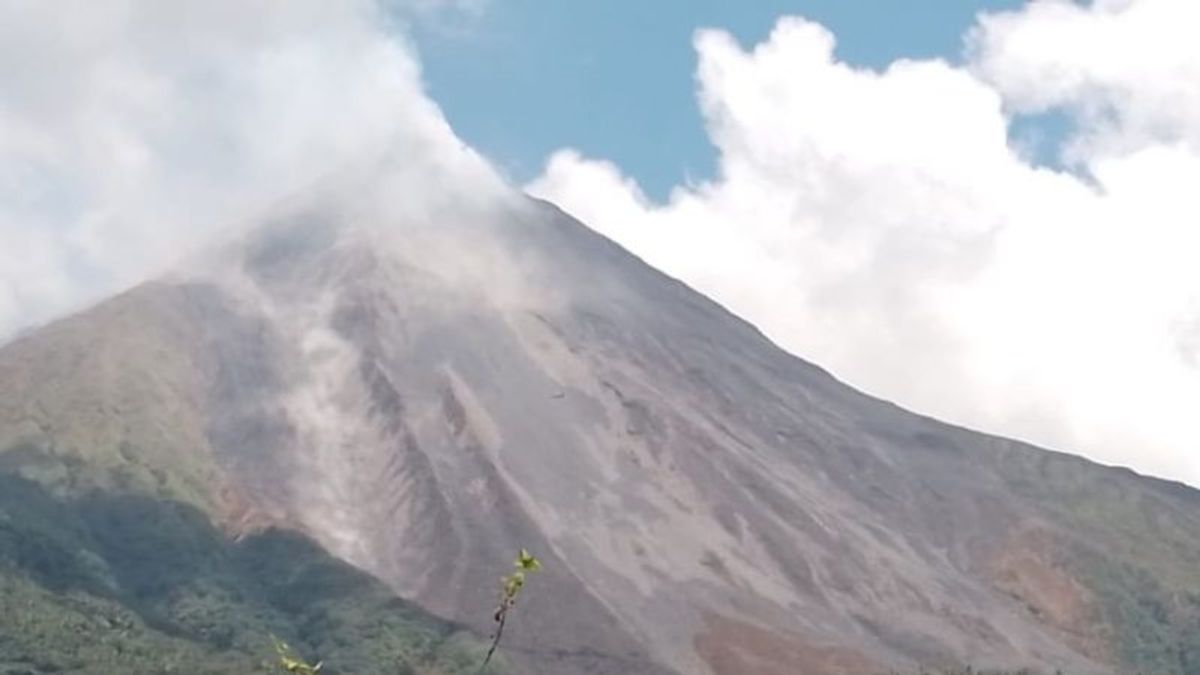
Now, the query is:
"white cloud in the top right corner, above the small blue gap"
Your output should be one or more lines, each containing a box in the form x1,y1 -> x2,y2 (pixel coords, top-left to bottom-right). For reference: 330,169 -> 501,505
970,0 -> 1200,159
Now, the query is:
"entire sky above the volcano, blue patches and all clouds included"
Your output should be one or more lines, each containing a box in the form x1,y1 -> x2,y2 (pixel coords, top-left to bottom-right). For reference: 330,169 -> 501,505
0,0 -> 1200,485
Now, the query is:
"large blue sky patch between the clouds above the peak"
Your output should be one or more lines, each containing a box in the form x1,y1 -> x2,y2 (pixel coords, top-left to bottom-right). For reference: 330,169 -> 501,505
414,0 -> 1022,199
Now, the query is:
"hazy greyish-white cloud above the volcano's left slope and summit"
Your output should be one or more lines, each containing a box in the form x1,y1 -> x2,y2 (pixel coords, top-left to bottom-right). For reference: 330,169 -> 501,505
0,0 -> 488,339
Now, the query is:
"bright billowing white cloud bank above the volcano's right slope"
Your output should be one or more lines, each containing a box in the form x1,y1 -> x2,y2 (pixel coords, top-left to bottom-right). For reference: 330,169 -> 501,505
527,0 -> 1200,484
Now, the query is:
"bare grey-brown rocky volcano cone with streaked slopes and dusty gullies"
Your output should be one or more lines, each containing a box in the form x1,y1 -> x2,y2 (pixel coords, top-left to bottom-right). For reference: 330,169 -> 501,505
0,174 -> 1200,675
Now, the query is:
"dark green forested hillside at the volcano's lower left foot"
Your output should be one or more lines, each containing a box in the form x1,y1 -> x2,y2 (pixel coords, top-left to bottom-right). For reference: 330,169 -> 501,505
0,472 -> 502,675
